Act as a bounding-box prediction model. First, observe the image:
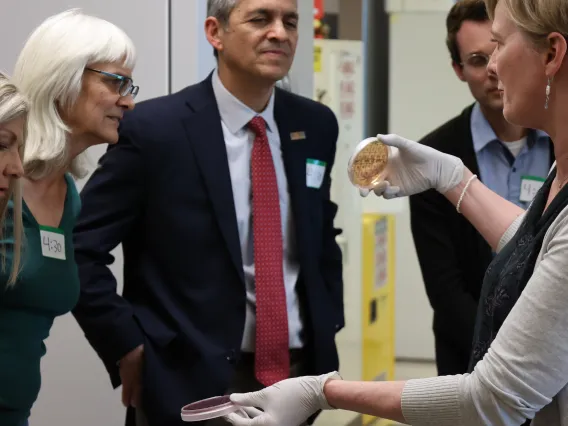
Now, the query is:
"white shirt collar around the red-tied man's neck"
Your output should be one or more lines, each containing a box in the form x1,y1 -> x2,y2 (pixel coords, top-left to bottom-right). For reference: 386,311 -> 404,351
212,69 -> 276,134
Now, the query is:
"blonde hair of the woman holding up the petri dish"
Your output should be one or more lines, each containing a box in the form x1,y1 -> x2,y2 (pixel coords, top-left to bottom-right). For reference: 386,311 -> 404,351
485,0 -> 568,46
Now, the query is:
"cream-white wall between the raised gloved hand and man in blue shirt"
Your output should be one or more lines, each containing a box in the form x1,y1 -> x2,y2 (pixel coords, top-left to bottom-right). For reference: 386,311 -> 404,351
385,8 -> 473,359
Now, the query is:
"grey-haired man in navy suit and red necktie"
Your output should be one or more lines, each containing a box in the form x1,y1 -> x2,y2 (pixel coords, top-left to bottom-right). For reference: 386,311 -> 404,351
74,0 -> 344,426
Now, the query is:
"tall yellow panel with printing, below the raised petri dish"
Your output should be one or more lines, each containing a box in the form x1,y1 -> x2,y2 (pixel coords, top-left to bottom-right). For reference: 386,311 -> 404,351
361,214 -> 395,426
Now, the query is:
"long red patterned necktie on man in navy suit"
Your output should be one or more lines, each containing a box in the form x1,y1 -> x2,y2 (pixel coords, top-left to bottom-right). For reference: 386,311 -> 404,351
249,116 -> 290,386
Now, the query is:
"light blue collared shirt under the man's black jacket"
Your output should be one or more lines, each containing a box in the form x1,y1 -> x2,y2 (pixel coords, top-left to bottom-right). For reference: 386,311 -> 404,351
471,103 -> 551,209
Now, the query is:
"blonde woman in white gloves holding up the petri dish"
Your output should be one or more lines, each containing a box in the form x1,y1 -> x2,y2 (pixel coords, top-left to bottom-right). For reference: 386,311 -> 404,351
229,0 -> 568,426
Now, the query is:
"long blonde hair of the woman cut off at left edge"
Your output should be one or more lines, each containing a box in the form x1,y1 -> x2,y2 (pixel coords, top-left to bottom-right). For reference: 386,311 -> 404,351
0,72 -> 28,287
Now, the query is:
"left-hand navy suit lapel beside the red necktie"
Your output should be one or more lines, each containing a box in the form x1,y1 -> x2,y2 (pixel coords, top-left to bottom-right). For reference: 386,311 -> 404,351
185,78 -> 244,282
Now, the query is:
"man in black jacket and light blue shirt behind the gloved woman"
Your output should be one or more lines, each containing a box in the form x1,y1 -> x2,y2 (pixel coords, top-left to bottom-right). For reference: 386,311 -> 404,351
410,0 -> 553,375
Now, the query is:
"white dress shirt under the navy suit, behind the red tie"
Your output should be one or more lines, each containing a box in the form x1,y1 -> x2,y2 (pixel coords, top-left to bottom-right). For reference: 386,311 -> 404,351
212,70 -> 303,352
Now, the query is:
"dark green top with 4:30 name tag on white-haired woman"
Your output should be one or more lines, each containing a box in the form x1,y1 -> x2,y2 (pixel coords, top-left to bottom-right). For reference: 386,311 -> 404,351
0,175 -> 81,426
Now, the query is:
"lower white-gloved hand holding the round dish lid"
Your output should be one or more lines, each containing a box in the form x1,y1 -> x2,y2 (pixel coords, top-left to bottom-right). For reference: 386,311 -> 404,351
225,372 -> 341,426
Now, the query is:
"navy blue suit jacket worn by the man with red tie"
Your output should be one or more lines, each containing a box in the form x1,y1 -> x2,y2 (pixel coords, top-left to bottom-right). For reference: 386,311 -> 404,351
73,76 -> 344,426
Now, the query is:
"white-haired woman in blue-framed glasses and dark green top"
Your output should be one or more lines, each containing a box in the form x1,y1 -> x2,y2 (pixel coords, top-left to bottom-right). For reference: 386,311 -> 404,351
0,10 -> 138,426
